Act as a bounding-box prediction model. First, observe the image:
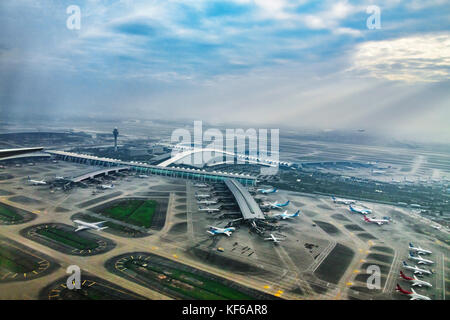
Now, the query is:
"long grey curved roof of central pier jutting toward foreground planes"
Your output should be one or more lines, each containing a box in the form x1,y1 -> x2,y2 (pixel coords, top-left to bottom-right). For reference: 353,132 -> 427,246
225,179 -> 264,220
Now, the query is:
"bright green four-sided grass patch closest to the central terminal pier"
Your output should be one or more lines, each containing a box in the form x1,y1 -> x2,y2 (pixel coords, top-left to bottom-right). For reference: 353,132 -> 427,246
100,200 -> 157,228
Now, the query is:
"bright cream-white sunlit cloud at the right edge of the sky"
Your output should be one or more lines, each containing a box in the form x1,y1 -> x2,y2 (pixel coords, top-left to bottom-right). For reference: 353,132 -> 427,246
351,33 -> 450,82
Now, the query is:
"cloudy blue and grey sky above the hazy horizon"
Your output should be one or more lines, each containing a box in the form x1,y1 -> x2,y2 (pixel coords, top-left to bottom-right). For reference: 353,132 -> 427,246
0,0 -> 450,143
